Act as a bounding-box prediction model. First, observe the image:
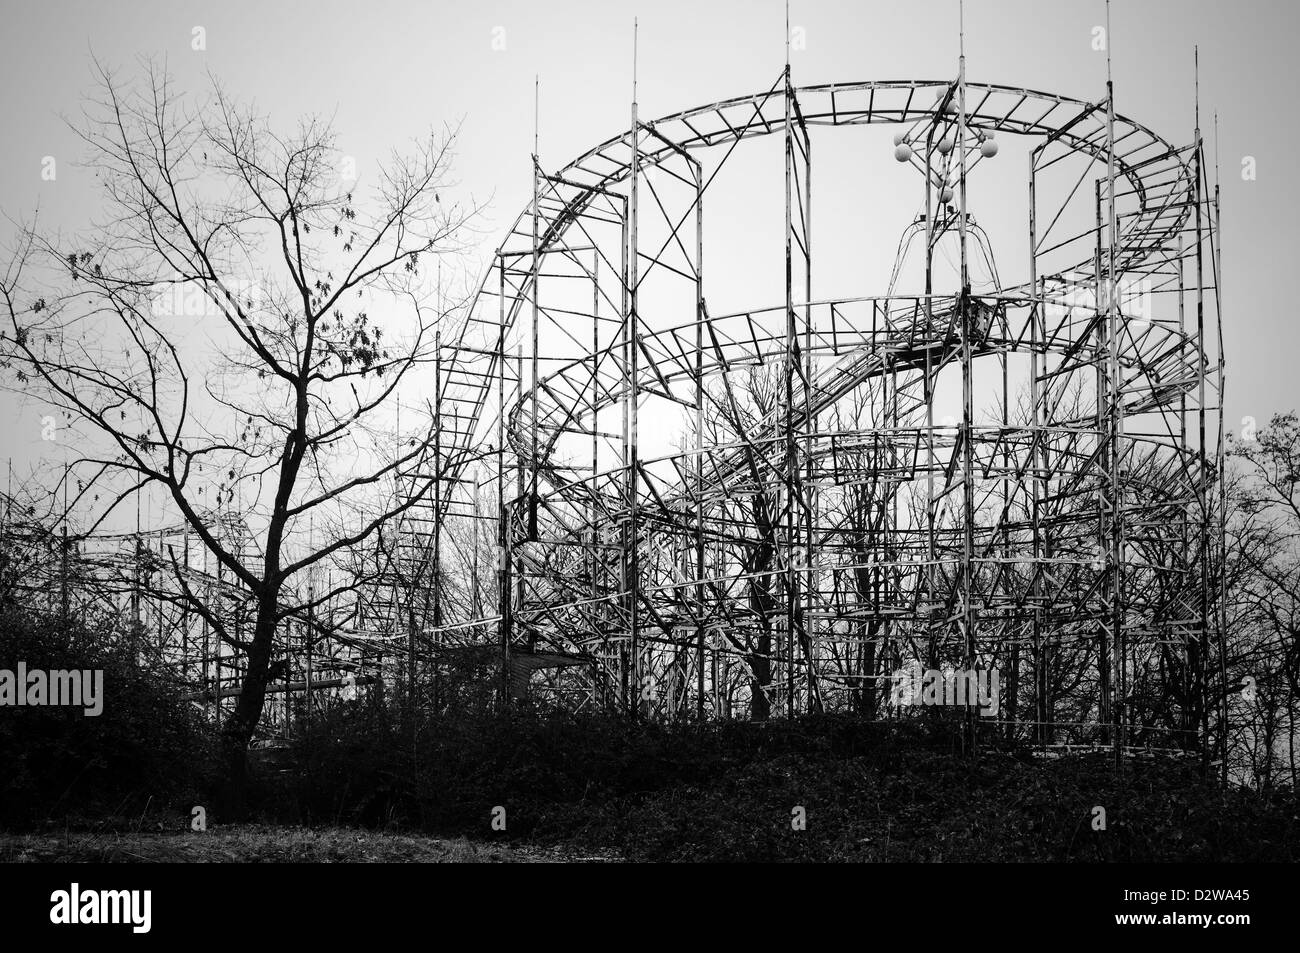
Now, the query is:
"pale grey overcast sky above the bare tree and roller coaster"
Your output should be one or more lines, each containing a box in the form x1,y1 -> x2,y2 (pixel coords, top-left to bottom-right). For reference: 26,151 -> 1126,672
0,0 -> 1300,512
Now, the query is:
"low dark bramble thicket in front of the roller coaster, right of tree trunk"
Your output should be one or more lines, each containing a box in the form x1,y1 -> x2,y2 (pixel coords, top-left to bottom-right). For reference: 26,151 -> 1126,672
263,703 -> 1300,861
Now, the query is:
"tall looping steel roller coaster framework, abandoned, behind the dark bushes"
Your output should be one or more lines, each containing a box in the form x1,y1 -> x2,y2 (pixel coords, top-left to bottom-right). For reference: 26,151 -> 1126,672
426,59 -> 1226,750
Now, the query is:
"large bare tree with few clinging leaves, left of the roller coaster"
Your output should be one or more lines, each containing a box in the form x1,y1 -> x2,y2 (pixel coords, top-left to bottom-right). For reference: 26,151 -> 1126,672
0,64 -> 480,814
